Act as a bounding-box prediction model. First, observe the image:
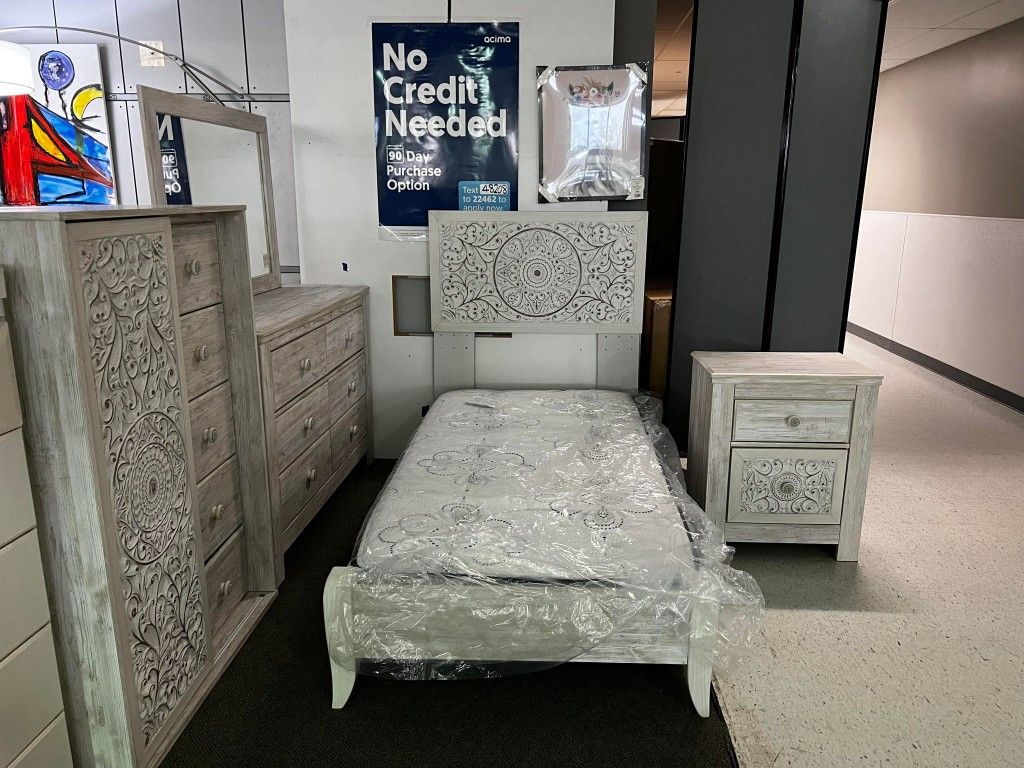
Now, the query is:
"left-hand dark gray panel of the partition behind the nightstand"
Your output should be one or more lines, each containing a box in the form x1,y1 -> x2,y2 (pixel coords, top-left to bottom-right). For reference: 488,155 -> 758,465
666,0 -> 794,445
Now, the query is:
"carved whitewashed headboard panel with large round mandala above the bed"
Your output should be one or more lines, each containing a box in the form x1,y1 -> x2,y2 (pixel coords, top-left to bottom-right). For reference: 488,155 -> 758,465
435,218 -> 644,326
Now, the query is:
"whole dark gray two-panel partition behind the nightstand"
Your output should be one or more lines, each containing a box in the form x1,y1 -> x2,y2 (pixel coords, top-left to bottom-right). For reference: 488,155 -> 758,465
666,0 -> 886,446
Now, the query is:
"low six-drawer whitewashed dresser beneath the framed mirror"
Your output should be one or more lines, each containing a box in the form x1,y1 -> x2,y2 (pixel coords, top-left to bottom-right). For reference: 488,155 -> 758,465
253,286 -> 372,562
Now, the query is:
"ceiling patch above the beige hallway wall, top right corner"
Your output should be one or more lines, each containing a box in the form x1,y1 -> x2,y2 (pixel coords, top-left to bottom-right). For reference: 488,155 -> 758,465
881,0 -> 1024,72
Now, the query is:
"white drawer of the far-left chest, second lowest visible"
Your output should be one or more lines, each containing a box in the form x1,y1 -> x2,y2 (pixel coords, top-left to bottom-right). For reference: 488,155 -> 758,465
0,626 -> 63,765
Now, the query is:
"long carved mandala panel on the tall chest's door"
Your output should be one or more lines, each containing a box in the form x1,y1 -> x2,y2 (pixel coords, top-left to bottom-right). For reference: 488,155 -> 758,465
79,227 -> 208,744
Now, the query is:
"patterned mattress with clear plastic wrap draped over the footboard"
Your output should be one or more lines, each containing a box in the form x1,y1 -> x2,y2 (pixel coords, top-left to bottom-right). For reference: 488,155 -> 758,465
325,390 -> 764,679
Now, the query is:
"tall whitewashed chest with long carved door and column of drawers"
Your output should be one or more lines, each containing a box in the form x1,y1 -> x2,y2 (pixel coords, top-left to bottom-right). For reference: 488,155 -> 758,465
0,207 -> 283,768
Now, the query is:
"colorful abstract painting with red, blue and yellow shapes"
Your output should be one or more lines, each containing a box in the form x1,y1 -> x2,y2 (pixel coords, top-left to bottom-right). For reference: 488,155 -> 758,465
0,44 -> 117,206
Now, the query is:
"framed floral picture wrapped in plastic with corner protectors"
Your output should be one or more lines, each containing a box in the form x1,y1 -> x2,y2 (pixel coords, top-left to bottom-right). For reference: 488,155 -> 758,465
537,62 -> 648,203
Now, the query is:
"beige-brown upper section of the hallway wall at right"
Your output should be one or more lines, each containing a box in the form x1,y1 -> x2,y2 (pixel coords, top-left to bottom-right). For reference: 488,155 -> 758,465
864,19 -> 1024,218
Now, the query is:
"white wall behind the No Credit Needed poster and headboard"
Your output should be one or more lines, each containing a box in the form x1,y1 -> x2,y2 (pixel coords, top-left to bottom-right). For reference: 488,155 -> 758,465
285,0 -> 614,457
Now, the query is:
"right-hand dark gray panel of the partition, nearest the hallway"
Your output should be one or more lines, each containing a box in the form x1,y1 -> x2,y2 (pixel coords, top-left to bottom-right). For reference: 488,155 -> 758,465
766,0 -> 885,352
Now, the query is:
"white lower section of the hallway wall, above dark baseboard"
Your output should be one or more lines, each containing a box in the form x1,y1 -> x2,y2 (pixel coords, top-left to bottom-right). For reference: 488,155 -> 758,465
849,211 -> 1024,395
